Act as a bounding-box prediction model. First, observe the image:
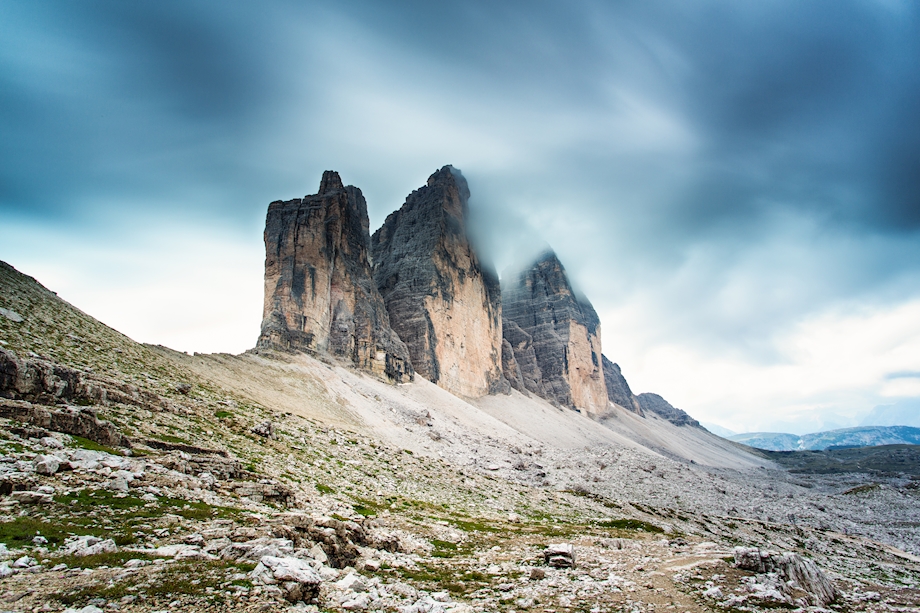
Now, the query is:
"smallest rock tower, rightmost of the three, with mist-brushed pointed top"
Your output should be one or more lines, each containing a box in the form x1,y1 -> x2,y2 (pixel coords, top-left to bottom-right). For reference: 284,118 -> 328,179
502,251 -> 607,415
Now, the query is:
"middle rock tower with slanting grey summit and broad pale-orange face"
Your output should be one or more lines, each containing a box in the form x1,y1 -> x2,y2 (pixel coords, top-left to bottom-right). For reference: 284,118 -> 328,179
371,166 -> 508,397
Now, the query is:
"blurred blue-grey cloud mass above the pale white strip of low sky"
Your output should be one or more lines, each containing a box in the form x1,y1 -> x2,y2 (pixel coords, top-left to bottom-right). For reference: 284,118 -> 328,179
0,0 -> 920,370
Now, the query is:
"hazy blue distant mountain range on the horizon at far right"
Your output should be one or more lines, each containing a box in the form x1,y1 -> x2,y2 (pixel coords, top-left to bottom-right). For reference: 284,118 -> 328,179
725,426 -> 920,451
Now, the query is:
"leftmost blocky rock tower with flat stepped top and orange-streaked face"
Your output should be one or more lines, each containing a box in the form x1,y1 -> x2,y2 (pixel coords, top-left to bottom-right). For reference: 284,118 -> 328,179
258,171 -> 412,381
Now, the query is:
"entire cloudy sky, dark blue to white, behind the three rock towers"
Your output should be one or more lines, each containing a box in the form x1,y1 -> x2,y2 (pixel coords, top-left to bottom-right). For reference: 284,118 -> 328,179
0,0 -> 920,434
